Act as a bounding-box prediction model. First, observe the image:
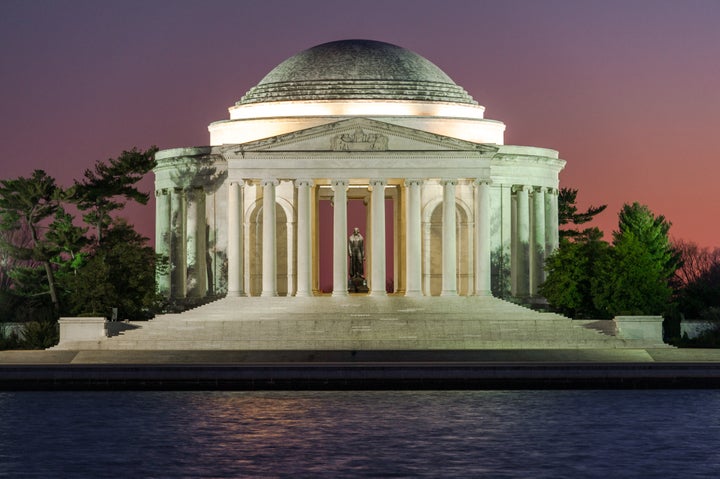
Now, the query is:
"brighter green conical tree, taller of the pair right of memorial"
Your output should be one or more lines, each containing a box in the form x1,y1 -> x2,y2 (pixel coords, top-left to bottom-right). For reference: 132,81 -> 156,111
592,203 -> 678,316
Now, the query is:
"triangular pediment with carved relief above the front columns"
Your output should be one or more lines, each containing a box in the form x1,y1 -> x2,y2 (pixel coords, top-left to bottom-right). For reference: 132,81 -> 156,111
223,118 -> 497,153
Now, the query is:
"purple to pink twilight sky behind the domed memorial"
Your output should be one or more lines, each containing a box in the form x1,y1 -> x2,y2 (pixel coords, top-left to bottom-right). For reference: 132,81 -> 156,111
0,0 -> 720,247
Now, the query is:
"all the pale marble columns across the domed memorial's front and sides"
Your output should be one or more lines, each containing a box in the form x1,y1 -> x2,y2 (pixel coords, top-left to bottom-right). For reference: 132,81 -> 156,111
156,178 -> 559,299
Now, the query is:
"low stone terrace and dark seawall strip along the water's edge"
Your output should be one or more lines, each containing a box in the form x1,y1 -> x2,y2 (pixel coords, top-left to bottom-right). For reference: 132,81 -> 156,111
0,348 -> 720,390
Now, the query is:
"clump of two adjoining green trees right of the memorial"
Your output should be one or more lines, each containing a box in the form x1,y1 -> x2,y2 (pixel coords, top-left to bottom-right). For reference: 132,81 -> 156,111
540,203 -> 678,318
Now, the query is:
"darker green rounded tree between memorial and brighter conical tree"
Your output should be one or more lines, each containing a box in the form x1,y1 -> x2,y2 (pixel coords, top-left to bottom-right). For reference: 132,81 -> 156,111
540,228 -> 610,318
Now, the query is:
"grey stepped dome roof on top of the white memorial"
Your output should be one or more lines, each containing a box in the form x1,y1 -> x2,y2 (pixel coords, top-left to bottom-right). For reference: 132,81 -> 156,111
237,40 -> 477,105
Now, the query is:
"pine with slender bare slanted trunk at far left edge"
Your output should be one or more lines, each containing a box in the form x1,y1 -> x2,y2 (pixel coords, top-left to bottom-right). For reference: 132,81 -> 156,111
0,170 -> 63,314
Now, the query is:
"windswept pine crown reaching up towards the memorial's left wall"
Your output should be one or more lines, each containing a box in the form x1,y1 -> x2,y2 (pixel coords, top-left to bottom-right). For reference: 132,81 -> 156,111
72,146 -> 158,243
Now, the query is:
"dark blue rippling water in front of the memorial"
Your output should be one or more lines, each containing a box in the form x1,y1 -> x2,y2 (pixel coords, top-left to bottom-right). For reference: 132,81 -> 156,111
0,390 -> 720,479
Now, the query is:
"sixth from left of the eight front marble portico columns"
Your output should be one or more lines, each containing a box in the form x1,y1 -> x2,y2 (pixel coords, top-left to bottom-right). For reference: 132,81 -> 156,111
405,180 -> 422,296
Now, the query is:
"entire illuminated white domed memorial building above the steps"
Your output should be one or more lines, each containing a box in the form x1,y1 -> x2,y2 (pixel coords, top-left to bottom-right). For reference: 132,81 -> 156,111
155,40 -> 565,300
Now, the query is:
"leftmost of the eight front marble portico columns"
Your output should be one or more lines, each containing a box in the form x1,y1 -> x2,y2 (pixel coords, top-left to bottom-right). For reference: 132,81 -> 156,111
227,180 -> 245,296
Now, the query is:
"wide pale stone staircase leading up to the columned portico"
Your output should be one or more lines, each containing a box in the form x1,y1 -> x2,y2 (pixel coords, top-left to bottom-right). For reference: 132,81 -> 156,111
53,295 -> 665,350
